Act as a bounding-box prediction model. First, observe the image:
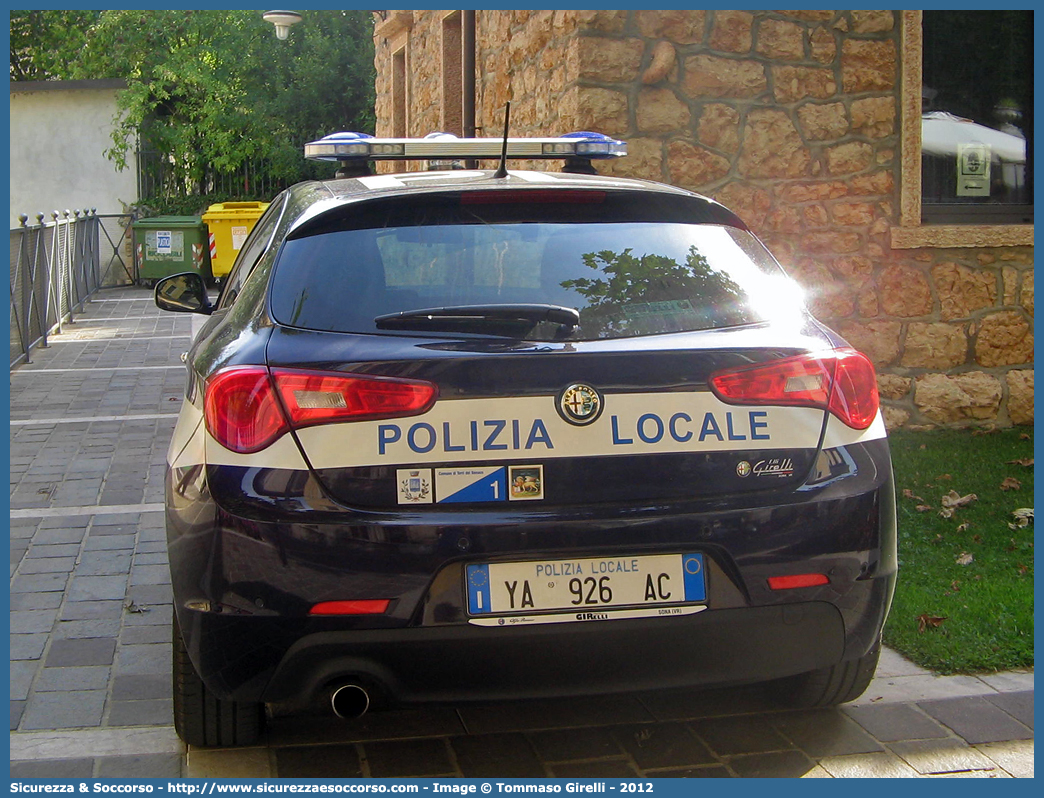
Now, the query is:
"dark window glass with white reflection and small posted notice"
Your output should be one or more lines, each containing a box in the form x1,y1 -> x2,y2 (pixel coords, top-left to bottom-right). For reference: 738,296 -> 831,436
921,10 -> 1034,225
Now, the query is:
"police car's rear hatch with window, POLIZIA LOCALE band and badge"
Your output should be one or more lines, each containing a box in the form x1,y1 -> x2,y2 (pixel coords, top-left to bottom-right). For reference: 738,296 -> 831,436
267,187 -> 832,512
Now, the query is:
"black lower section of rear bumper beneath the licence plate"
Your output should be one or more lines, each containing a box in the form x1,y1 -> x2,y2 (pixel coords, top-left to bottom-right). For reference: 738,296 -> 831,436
181,602 -> 846,703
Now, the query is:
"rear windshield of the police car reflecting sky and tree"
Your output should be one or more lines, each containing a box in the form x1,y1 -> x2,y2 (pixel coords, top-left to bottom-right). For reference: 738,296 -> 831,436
271,192 -> 800,341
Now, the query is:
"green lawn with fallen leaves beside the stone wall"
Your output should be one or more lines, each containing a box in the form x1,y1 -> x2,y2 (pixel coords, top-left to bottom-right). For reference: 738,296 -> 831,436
884,427 -> 1034,674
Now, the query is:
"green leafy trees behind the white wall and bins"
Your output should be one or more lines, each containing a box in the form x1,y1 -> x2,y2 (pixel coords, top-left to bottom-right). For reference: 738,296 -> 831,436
11,9 -> 374,198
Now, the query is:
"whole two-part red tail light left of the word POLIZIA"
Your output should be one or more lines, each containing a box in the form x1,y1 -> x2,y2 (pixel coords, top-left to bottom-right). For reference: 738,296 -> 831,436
204,366 -> 438,454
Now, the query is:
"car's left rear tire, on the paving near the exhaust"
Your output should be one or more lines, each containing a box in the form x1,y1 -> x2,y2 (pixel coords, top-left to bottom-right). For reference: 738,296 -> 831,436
171,614 -> 264,747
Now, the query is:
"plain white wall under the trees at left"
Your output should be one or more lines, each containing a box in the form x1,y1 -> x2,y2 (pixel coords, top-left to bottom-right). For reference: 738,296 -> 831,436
10,80 -> 138,227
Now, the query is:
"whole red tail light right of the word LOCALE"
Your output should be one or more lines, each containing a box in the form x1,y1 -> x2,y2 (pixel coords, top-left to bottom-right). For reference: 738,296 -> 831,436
710,349 -> 880,429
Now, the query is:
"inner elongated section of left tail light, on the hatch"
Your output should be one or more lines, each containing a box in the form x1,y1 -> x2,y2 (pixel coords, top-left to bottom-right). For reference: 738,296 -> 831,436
271,369 -> 438,428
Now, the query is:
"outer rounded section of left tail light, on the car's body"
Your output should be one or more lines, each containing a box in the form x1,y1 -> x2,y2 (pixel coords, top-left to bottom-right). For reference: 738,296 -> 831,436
204,366 -> 287,454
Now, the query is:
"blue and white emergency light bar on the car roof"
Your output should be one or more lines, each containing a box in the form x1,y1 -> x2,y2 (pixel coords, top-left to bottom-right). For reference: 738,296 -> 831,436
305,132 -> 627,161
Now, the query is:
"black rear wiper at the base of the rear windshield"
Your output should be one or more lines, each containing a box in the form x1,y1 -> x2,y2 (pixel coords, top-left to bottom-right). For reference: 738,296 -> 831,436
374,304 -> 580,337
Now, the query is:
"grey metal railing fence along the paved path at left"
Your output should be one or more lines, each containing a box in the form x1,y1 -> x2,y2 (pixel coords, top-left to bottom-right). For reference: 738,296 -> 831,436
10,209 -> 138,369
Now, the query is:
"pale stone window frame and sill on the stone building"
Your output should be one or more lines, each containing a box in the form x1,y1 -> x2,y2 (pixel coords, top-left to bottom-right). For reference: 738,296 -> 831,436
892,10 -> 1034,249
